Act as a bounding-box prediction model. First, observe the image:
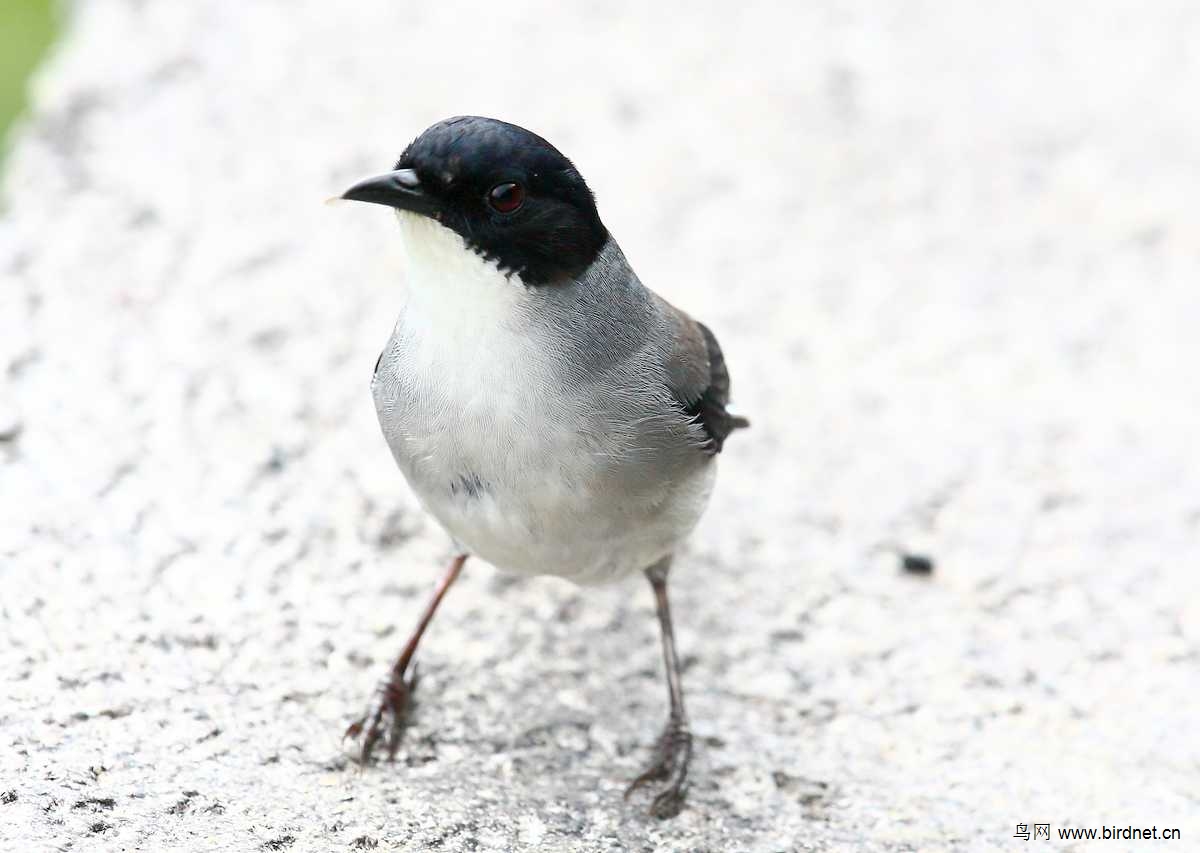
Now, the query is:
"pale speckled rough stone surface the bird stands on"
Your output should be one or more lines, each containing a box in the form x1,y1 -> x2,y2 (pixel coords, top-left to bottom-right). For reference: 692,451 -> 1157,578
0,0 -> 1200,851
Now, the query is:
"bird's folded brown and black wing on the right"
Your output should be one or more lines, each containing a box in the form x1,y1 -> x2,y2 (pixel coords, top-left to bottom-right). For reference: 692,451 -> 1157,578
660,300 -> 750,453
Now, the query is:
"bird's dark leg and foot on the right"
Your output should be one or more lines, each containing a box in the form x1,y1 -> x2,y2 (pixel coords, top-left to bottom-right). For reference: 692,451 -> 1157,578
625,558 -> 691,818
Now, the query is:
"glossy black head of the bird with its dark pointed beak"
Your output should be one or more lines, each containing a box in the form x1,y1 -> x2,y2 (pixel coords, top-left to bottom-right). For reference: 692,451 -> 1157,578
342,115 -> 608,284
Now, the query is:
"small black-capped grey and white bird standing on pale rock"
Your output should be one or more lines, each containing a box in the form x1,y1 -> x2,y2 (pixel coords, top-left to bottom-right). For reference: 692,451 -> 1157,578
342,116 -> 749,817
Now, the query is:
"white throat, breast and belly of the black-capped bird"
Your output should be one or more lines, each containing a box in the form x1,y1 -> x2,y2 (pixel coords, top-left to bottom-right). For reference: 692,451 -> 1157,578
373,212 -> 714,582
